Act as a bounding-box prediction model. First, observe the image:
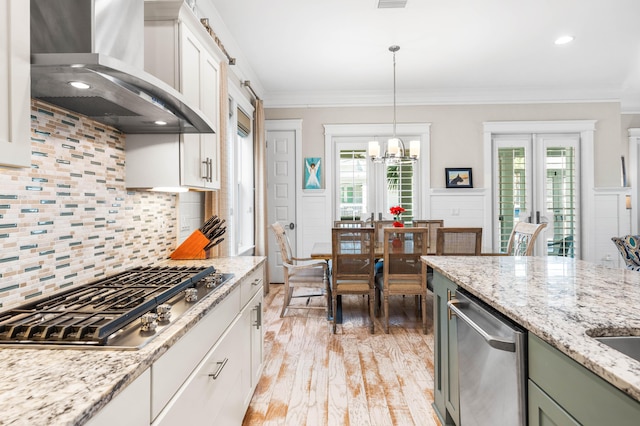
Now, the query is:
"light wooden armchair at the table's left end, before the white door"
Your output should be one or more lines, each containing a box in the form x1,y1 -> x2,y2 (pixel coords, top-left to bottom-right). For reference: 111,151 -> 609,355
271,222 -> 330,318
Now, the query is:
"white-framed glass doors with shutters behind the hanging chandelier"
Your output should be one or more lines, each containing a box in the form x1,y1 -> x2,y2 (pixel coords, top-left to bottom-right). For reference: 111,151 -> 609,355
323,123 -> 431,231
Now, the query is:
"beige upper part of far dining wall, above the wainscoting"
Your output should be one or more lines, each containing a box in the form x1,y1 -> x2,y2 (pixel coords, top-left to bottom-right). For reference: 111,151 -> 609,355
265,102 -> 628,188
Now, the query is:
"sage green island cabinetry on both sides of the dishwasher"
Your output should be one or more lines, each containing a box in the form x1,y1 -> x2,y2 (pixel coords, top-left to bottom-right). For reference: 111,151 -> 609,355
433,272 -> 640,426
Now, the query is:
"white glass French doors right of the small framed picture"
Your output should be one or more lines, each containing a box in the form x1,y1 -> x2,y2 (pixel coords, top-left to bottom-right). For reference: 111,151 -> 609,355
493,134 -> 580,257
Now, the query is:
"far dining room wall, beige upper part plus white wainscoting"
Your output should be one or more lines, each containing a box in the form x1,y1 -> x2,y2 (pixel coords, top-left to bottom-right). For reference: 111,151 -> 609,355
265,102 -> 640,266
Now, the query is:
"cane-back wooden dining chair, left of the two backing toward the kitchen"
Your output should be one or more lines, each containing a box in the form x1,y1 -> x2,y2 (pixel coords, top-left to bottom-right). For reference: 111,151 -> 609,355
331,228 -> 375,334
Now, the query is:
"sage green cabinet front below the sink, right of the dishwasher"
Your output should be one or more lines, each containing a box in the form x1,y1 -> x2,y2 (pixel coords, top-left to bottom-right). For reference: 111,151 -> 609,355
528,333 -> 640,426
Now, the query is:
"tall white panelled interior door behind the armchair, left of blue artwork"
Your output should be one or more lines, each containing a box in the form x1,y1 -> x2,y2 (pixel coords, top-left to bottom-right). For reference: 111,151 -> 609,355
267,130 -> 297,283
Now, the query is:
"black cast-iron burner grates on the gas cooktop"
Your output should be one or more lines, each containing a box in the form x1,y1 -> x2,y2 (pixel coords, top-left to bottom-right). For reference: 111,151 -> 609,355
0,266 -> 215,345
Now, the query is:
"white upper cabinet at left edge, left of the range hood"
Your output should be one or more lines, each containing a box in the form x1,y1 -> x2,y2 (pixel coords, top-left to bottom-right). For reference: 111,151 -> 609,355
0,0 -> 31,167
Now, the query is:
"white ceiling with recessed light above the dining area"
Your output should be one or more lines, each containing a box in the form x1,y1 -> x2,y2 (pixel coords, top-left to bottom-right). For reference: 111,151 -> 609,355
205,0 -> 640,112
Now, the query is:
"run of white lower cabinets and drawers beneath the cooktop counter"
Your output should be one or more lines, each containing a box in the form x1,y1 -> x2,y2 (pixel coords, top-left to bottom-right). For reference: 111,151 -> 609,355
88,263 -> 265,426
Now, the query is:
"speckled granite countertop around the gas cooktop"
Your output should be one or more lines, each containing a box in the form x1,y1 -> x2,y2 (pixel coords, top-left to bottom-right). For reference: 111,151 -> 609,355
0,256 -> 266,426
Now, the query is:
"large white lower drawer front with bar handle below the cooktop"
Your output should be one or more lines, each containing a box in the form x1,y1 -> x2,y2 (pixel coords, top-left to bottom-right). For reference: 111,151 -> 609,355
153,314 -> 246,426
